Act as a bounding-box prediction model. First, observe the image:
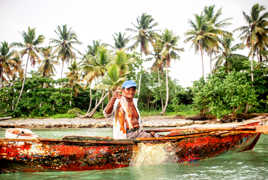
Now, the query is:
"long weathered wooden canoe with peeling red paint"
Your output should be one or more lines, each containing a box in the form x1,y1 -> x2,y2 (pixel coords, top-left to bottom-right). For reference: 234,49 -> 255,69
0,123 -> 260,173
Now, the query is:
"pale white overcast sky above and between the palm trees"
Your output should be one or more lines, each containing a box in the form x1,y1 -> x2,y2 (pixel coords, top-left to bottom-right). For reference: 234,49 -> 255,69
0,0 -> 268,87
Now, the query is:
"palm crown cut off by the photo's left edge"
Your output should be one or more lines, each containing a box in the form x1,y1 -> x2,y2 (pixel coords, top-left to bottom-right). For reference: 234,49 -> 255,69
0,41 -> 20,88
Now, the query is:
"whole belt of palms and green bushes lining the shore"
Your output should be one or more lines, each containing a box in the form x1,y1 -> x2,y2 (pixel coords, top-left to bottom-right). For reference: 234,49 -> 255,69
0,4 -> 268,118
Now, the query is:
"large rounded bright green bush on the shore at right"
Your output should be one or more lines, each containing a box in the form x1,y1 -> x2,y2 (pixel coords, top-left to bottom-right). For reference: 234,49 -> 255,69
193,71 -> 258,117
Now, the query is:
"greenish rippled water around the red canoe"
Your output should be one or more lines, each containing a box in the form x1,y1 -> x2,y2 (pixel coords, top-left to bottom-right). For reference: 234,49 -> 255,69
0,128 -> 268,180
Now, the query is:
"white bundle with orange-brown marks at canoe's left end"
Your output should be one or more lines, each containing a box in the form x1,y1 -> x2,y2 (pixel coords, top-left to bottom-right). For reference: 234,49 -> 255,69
5,128 -> 38,139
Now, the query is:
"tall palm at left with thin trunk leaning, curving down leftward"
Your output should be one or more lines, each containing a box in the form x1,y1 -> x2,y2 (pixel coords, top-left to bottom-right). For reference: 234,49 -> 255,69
14,27 -> 45,109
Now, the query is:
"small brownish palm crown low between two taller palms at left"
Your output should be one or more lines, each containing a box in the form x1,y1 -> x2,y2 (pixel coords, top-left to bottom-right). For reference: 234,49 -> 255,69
38,46 -> 57,77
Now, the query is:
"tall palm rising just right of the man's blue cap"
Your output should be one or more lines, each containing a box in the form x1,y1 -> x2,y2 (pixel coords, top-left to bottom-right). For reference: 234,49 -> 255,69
127,13 -> 158,97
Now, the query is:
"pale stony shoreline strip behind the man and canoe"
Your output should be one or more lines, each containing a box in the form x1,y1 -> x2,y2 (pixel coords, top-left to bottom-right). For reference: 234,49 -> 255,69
0,114 -> 268,129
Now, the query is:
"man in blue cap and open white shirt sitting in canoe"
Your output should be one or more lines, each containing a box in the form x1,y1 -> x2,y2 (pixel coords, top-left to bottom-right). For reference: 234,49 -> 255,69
103,80 -> 154,139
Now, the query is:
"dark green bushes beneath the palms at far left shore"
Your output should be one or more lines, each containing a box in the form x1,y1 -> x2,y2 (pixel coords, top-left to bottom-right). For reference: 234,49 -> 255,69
0,76 -> 91,117
